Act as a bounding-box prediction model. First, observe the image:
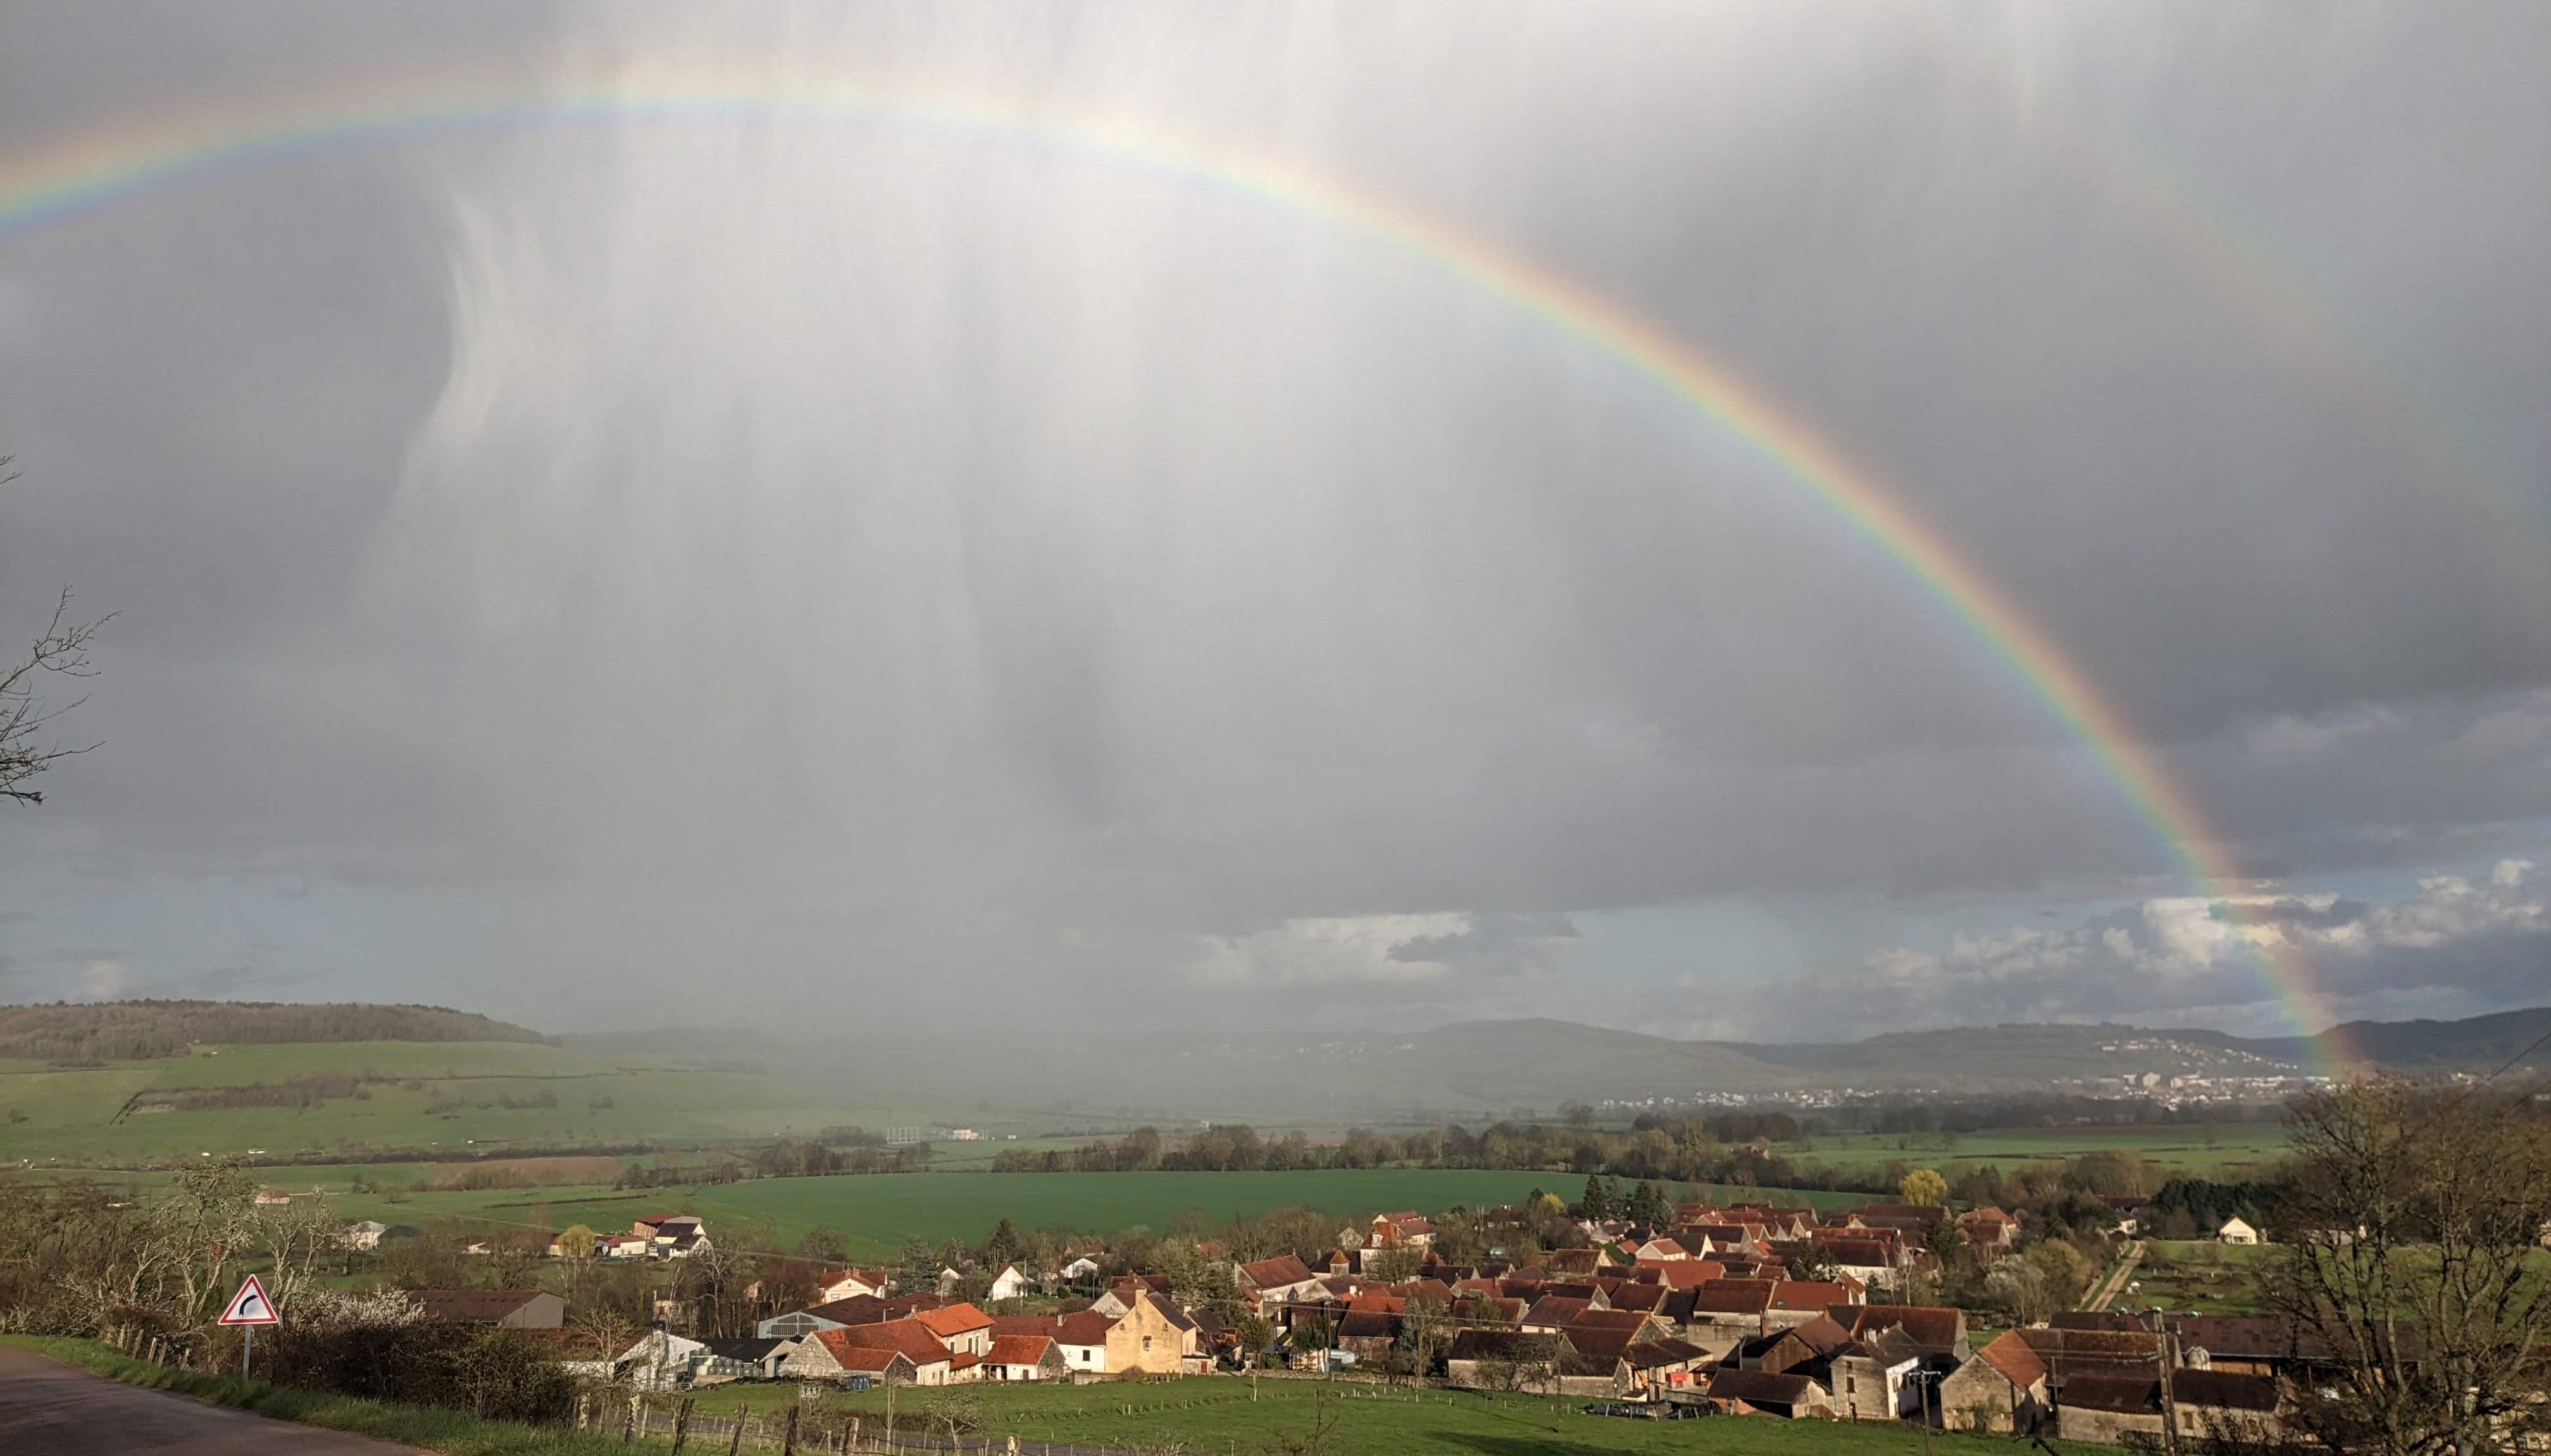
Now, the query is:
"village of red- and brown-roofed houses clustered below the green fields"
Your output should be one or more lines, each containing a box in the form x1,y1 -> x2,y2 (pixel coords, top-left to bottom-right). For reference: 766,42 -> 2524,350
370,1204 -> 2316,1443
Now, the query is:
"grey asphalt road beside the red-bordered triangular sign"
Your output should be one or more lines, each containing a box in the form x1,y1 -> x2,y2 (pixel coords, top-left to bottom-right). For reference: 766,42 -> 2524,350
0,1347 -> 418,1456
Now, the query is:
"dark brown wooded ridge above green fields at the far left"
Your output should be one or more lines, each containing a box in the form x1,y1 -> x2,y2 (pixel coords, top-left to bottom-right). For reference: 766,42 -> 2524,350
0,1002 -> 556,1061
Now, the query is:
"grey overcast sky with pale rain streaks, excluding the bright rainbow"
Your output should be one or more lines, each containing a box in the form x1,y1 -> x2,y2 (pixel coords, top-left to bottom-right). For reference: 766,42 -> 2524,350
0,0 -> 2551,1038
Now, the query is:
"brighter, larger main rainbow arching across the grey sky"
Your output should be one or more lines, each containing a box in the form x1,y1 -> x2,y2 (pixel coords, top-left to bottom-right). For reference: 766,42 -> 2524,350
0,69 -> 2334,1068
